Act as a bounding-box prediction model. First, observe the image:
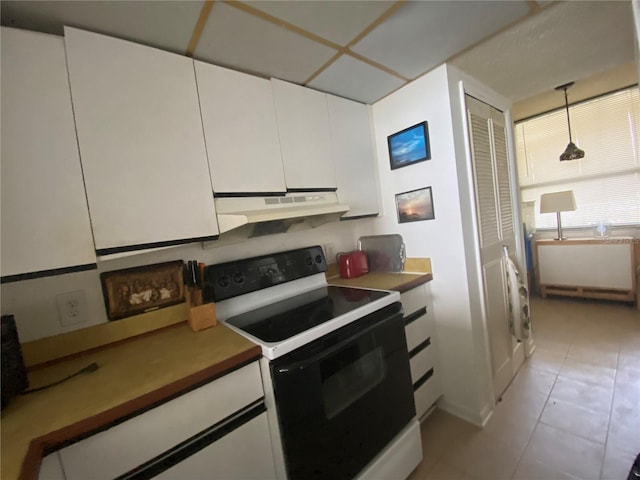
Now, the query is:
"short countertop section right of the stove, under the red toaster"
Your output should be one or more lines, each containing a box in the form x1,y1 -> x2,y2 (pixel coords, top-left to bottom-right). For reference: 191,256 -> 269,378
327,258 -> 433,293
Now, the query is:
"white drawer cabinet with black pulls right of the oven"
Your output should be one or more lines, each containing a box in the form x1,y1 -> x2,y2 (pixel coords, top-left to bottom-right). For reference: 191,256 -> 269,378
400,284 -> 442,418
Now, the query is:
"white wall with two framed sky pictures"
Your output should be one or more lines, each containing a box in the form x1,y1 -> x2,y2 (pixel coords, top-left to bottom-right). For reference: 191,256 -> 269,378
368,65 -> 487,423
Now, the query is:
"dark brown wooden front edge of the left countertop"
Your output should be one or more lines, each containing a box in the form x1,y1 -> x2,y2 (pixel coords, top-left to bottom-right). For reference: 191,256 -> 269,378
19,345 -> 262,480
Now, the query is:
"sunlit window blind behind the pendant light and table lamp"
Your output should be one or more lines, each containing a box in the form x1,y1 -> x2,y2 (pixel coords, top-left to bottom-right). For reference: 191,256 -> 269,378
515,87 -> 640,228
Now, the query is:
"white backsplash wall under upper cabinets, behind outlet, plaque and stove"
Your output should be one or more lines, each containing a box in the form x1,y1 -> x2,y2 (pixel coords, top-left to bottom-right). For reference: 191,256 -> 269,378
0,220 -> 362,343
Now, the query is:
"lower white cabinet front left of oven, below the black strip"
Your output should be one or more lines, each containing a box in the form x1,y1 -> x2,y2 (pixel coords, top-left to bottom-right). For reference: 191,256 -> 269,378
154,413 -> 276,480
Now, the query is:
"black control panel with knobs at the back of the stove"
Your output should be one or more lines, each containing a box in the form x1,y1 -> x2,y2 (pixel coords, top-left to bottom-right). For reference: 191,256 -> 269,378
203,246 -> 327,302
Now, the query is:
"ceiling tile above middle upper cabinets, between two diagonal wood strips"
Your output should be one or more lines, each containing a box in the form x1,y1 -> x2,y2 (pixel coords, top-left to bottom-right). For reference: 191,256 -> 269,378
194,3 -> 336,83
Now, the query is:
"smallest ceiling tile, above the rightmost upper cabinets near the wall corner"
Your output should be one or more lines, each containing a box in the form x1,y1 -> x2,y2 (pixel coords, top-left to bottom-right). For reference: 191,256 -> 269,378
308,55 -> 404,104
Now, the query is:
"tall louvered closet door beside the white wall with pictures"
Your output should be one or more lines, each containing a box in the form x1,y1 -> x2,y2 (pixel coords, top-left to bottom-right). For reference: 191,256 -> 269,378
466,95 -> 524,398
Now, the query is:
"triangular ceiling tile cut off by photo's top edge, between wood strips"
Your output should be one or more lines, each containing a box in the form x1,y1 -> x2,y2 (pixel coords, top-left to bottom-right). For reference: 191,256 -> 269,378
246,0 -> 395,46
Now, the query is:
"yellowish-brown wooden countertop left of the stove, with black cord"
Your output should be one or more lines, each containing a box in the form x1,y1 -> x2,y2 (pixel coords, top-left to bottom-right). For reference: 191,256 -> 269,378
0,323 -> 261,479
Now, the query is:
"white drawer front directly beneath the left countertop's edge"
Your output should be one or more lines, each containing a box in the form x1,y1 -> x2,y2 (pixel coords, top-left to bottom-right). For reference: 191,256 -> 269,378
59,362 -> 264,480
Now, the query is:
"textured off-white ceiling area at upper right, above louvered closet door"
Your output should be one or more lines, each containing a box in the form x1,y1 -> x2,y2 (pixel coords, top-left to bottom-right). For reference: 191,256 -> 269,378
452,1 -> 636,101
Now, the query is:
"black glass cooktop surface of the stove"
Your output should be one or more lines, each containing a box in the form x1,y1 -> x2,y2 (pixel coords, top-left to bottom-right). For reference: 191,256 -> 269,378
226,286 -> 390,343
